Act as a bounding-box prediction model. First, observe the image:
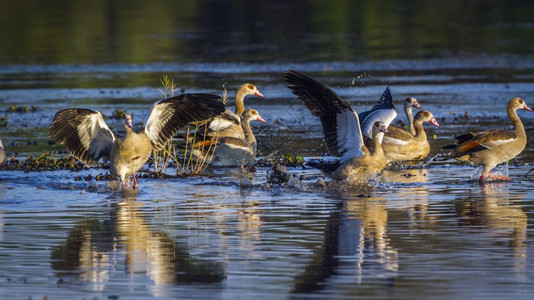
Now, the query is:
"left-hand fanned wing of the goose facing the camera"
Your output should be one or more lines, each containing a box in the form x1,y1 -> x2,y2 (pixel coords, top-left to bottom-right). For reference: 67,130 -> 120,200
48,108 -> 115,164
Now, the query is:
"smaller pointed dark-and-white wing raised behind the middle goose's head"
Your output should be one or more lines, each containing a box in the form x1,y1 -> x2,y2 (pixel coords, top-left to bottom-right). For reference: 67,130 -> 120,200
358,86 -> 397,142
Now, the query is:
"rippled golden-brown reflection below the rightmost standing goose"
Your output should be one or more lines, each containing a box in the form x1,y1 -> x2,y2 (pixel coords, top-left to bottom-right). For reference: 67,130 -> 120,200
456,183 -> 528,281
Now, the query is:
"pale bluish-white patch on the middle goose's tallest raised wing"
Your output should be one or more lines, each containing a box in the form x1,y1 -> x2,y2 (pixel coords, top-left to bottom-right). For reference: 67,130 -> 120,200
336,109 -> 363,163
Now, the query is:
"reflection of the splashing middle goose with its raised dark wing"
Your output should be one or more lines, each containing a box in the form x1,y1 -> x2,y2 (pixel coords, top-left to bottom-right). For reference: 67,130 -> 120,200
292,197 -> 399,294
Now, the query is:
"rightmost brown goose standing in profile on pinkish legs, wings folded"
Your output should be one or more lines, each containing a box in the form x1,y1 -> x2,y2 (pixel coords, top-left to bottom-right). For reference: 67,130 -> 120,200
443,98 -> 532,184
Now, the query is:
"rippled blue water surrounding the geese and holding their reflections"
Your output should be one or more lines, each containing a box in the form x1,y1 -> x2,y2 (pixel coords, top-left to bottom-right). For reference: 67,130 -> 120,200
0,1 -> 534,299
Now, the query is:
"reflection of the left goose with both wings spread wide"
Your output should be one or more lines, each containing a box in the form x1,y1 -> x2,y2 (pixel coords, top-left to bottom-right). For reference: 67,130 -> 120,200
51,201 -> 226,297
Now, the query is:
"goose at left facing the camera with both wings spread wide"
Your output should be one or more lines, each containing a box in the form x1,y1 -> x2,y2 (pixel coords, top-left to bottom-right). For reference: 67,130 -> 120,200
48,94 -> 225,190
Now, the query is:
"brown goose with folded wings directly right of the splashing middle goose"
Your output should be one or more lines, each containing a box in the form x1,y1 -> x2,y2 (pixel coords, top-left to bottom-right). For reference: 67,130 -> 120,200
382,110 -> 439,163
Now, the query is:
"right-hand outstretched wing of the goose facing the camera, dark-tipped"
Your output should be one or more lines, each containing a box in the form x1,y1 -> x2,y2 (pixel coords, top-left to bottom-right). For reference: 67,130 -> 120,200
145,94 -> 225,150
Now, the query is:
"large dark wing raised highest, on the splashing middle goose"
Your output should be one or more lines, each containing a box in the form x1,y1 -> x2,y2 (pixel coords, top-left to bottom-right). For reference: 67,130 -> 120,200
284,70 -> 363,162
